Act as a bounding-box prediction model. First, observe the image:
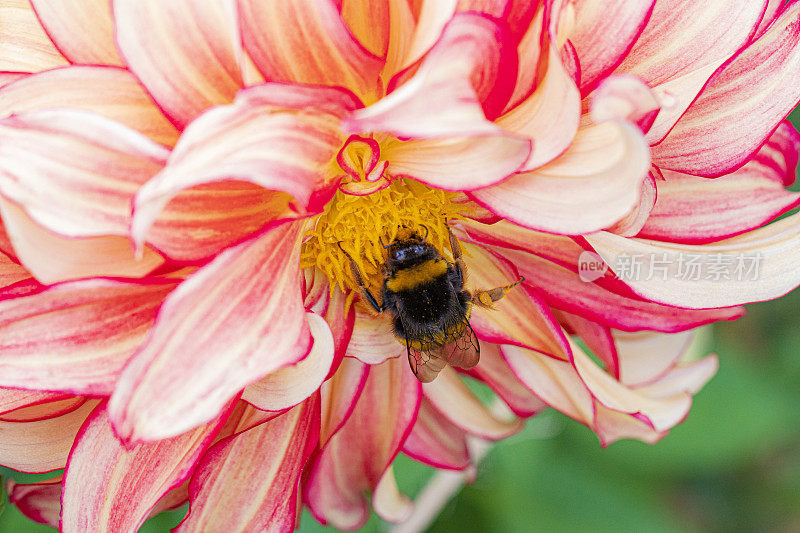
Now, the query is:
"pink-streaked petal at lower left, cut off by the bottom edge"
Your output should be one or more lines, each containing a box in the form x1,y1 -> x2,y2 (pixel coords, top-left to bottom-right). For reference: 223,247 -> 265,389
61,404 -> 224,533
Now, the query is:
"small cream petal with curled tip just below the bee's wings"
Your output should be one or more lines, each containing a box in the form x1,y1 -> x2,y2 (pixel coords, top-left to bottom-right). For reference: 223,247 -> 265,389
422,367 -> 524,440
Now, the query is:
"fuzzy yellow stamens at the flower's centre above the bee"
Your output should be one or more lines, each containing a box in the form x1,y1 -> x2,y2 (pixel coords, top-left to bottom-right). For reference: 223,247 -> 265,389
300,178 -> 458,296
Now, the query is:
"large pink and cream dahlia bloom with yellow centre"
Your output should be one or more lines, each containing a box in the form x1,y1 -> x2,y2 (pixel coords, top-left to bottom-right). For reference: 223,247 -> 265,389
0,0 -> 800,531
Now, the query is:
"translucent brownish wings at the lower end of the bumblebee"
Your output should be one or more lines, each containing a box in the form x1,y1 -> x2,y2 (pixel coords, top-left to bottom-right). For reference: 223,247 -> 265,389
406,322 -> 481,383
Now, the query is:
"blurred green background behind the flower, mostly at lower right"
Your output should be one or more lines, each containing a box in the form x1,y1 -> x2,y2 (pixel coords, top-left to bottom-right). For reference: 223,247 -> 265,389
0,113 -> 800,533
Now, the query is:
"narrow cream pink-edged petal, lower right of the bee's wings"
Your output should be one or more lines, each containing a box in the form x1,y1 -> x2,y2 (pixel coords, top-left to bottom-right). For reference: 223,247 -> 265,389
500,345 -> 594,425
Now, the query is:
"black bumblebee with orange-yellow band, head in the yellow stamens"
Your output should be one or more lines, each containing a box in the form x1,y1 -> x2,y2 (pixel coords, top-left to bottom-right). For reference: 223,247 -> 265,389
343,222 -> 523,383
